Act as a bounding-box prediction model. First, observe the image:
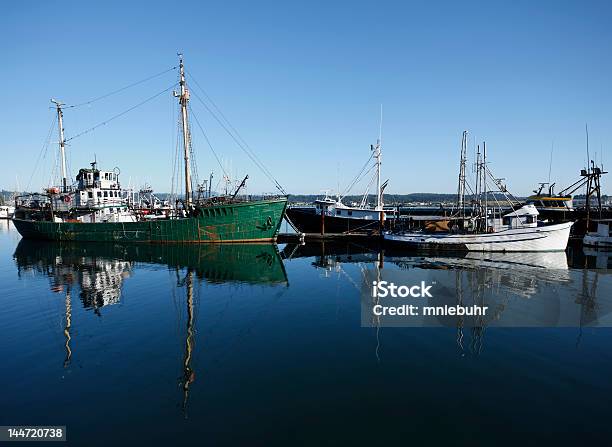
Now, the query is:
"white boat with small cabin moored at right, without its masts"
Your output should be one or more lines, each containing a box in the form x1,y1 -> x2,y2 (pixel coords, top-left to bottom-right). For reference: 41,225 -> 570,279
384,205 -> 573,252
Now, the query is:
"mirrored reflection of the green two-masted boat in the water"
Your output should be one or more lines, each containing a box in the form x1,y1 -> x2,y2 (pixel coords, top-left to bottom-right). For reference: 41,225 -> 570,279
14,239 -> 288,416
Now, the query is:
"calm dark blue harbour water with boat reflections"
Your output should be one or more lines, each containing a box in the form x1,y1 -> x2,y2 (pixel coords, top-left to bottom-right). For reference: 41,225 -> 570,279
0,221 -> 612,445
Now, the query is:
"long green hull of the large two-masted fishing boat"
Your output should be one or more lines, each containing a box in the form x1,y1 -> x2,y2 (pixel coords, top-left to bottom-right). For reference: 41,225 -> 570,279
13,198 -> 287,243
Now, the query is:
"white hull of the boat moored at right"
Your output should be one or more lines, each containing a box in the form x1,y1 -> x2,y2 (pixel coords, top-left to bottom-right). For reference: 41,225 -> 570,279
384,222 -> 573,252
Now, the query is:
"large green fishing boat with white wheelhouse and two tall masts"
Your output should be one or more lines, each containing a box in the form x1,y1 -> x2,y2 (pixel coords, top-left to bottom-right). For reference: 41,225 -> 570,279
13,55 -> 287,244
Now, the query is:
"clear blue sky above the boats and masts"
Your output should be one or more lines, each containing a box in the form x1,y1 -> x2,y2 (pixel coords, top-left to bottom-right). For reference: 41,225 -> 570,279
0,1 -> 612,195
